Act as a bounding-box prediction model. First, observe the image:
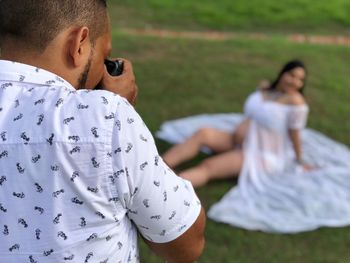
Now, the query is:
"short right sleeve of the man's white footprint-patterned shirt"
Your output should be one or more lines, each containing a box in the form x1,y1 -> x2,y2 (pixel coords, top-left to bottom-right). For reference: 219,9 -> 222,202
113,99 -> 201,243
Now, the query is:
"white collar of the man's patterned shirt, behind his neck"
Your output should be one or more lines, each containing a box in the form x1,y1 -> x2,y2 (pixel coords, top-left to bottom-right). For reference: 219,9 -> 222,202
0,60 -> 75,91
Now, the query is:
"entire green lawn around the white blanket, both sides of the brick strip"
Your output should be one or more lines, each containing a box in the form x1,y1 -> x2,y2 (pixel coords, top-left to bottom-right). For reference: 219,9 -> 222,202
110,0 -> 350,263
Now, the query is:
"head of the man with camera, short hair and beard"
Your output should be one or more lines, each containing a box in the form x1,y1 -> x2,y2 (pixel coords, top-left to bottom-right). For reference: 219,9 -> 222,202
0,0 -> 111,88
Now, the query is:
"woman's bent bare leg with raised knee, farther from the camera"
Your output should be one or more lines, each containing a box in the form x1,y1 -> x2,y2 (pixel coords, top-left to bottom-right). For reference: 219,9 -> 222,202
162,128 -> 233,168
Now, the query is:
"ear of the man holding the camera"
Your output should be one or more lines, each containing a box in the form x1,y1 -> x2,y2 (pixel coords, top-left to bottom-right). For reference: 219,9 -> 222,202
69,27 -> 92,67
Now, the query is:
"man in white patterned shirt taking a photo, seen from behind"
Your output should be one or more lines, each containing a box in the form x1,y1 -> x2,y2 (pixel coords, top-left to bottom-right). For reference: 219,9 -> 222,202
0,0 -> 205,263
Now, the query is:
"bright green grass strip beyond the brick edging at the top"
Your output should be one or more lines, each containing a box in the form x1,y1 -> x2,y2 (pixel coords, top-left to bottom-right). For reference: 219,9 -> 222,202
110,0 -> 350,34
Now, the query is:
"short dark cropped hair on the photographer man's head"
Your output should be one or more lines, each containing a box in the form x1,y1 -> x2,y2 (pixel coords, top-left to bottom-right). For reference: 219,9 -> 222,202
0,0 -> 107,51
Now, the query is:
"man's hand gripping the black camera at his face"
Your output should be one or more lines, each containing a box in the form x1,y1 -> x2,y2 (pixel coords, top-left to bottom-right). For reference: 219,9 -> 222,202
100,58 -> 138,106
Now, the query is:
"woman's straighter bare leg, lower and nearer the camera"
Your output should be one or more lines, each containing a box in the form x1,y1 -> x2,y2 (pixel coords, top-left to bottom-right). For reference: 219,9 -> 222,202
179,150 -> 243,187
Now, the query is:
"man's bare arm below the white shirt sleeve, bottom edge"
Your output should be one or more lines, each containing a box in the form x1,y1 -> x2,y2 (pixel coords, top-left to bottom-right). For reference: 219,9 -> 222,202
144,208 -> 206,263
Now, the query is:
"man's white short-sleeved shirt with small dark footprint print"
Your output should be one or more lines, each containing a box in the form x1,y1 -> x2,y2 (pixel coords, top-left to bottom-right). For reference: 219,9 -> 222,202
0,60 -> 201,263
